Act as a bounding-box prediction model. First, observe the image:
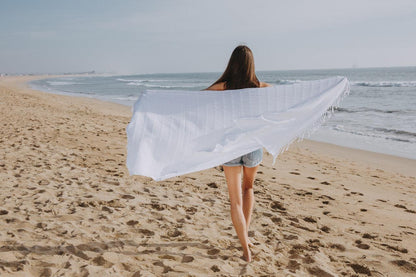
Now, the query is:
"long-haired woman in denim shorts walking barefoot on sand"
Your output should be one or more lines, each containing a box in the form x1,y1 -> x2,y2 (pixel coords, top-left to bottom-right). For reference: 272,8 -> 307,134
206,45 -> 270,262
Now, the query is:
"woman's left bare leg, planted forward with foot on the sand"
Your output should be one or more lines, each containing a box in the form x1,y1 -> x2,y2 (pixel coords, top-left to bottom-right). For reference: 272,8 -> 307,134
224,166 -> 251,262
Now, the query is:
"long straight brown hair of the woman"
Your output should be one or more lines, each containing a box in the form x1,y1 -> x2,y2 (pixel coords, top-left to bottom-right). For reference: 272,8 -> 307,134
212,45 -> 260,89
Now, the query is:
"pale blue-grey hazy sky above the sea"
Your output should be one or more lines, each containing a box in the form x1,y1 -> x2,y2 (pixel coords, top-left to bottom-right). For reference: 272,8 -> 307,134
0,0 -> 416,74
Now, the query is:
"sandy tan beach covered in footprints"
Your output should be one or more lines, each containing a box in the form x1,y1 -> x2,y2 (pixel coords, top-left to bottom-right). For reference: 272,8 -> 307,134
0,76 -> 416,277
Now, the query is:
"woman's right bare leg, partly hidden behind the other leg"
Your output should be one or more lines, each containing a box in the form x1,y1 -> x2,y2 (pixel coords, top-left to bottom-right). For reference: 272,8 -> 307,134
243,166 -> 259,232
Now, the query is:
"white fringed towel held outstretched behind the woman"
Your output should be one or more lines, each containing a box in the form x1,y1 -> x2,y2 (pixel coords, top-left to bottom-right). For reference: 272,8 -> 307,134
127,76 -> 349,181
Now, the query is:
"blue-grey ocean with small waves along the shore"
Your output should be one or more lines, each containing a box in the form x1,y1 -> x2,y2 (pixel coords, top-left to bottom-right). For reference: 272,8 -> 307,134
30,67 -> 416,159
